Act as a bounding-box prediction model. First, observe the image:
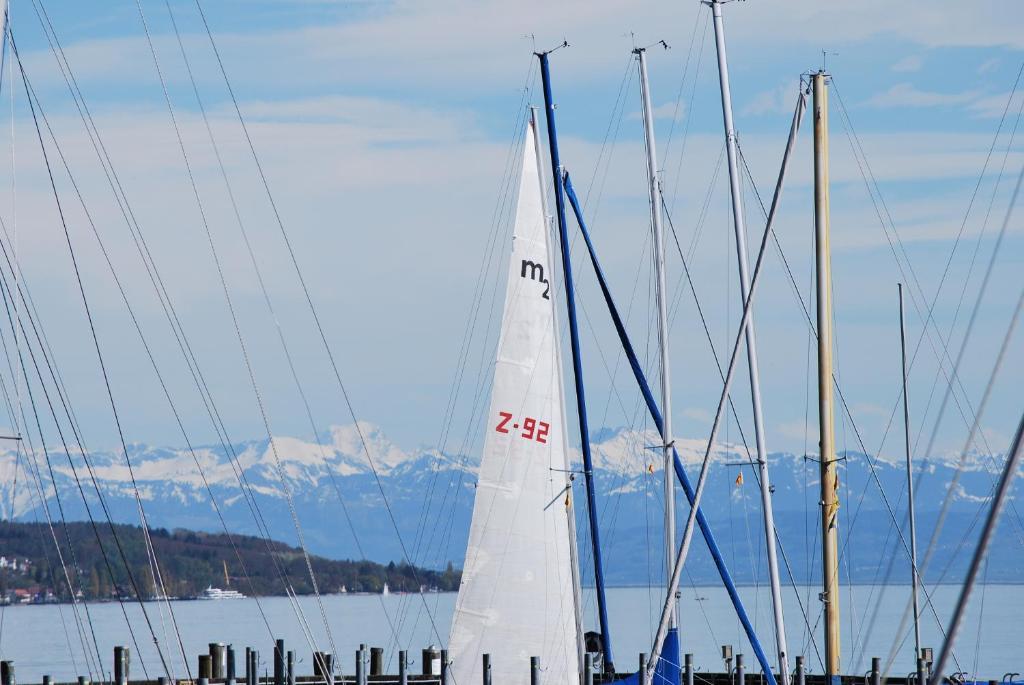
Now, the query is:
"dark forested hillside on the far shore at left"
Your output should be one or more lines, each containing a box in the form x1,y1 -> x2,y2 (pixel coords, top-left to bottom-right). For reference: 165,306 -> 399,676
0,522 -> 459,602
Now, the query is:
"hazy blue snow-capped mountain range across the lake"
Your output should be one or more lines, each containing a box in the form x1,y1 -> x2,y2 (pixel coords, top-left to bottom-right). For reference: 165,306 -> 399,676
0,423 -> 1024,584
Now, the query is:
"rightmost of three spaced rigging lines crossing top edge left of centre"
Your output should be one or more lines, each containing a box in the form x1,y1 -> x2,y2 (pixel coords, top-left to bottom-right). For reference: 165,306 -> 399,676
192,0 -> 441,640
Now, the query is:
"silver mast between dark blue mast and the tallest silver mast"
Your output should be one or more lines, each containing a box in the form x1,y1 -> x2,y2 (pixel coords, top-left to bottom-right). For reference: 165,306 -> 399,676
633,47 -> 677,629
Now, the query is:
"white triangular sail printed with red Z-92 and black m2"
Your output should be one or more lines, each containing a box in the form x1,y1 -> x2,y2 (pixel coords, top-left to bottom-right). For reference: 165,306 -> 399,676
449,118 -> 580,685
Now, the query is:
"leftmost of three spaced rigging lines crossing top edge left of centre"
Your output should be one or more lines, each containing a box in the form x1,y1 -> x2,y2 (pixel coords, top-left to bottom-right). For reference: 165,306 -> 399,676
135,0 -> 338,658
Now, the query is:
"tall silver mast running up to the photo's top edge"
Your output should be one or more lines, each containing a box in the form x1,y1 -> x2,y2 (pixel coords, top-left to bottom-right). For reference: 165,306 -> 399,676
711,0 -> 790,685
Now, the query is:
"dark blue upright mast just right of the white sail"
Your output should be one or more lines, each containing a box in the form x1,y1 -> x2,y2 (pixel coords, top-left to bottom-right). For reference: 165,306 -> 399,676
537,52 -> 614,673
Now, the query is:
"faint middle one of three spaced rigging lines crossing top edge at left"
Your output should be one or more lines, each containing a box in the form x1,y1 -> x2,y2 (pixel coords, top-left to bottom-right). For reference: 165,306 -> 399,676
165,1 -> 397,650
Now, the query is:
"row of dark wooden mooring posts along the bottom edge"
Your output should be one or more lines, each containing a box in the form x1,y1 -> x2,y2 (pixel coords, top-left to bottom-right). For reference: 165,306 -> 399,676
0,640 -> 932,685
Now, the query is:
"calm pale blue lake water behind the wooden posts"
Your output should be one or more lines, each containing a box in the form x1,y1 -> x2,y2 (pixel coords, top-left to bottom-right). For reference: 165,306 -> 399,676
0,586 -> 1024,683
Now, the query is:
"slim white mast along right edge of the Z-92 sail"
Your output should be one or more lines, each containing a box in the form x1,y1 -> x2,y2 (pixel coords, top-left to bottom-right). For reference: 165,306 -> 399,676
529,105 -> 587,668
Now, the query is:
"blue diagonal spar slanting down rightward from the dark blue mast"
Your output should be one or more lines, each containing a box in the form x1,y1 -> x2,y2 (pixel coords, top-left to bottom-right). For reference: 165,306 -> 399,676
561,169 -> 776,685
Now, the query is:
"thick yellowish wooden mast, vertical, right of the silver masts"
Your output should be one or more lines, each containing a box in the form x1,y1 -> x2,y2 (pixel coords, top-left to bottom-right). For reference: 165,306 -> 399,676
811,71 -> 840,683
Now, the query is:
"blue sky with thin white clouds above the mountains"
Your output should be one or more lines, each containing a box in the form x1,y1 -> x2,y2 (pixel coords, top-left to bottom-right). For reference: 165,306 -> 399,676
0,0 -> 1024,456
